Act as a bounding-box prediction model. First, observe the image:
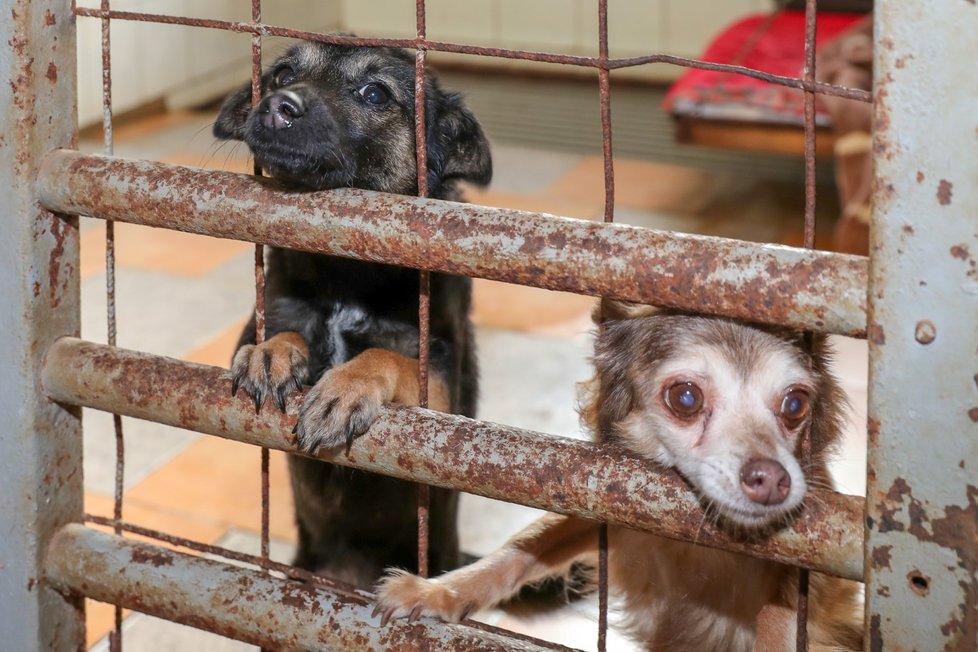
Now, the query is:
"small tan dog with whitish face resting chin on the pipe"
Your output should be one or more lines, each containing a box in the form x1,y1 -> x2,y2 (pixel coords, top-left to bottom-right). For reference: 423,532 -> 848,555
378,302 -> 861,652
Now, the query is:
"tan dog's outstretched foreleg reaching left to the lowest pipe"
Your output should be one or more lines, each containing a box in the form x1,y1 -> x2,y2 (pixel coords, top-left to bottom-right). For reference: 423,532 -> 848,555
377,514 -> 599,622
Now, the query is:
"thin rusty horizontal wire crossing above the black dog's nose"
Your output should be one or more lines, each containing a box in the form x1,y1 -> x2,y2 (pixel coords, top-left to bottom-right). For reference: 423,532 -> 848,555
75,7 -> 873,103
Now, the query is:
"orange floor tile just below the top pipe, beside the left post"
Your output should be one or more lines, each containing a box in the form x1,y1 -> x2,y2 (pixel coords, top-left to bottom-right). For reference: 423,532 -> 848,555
81,222 -> 252,280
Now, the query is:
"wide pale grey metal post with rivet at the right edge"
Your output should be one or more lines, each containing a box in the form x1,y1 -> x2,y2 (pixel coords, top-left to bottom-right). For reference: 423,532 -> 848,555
865,2 -> 978,651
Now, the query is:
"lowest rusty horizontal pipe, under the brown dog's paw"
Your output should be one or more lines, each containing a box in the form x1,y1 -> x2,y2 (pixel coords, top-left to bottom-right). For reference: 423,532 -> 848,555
44,524 -> 554,652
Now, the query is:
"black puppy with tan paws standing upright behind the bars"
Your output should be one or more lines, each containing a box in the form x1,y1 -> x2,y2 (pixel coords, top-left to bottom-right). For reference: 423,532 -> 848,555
214,42 -> 492,586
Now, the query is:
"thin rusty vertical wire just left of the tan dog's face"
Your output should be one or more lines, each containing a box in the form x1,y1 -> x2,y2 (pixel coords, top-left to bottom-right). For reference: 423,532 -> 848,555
598,0 -> 615,652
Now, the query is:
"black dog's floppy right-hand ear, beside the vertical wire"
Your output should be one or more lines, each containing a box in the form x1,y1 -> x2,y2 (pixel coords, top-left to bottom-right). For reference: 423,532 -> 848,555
426,93 -> 492,191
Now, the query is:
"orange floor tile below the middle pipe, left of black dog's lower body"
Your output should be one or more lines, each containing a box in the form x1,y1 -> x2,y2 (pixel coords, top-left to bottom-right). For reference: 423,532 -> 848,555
129,437 -> 295,541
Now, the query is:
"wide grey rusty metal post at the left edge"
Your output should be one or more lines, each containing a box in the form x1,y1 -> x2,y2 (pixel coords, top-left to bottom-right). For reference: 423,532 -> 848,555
0,0 -> 85,650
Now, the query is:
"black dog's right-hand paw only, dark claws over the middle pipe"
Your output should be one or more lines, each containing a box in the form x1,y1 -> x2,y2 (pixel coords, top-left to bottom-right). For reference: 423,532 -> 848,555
293,363 -> 389,453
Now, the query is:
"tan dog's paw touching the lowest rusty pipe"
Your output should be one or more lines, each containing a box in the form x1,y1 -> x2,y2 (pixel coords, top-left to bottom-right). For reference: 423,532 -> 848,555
374,570 -> 472,626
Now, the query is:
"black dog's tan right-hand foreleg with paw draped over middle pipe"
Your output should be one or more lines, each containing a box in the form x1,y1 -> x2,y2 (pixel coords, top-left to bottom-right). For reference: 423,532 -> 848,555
295,349 -> 451,452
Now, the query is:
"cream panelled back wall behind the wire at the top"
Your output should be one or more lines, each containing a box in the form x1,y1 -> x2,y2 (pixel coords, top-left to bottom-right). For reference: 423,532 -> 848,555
78,0 -> 773,126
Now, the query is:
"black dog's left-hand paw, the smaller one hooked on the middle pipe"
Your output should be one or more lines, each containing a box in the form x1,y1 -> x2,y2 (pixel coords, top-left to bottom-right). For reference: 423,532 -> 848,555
231,333 -> 309,412
